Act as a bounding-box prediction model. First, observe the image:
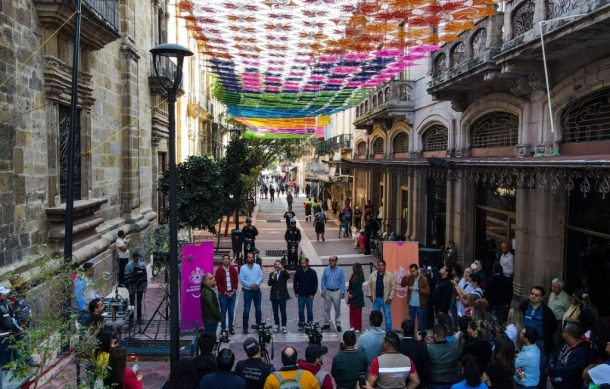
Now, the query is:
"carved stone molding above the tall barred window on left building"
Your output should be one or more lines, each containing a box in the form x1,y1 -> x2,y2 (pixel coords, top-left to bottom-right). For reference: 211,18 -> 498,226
44,56 -> 95,109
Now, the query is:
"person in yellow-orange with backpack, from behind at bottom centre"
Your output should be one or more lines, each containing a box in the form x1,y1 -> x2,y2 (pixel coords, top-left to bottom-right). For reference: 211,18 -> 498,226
263,346 -> 320,389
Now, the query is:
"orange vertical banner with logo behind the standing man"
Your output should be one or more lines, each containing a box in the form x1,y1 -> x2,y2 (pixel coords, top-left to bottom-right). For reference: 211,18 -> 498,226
383,242 -> 419,328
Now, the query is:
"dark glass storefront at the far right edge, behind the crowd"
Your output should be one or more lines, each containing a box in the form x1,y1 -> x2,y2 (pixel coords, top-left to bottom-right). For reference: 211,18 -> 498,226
564,186 -> 610,317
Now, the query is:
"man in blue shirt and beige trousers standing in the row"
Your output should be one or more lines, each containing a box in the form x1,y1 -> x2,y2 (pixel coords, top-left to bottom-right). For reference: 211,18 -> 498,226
320,255 -> 345,332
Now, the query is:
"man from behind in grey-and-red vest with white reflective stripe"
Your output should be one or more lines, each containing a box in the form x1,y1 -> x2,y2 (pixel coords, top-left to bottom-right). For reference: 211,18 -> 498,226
366,332 -> 419,389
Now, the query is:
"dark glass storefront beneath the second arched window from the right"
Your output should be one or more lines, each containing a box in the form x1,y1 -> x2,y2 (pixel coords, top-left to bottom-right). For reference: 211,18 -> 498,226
467,185 -> 517,274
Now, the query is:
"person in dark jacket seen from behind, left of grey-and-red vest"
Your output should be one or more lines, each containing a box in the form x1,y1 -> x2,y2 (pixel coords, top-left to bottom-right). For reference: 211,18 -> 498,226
330,331 -> 367,389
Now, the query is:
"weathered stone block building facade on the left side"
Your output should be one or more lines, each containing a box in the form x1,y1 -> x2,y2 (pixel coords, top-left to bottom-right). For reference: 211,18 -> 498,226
0,0 -> 176,292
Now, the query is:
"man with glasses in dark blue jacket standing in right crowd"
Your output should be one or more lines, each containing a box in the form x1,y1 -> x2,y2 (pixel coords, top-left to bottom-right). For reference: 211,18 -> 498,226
519,286 -> 557,389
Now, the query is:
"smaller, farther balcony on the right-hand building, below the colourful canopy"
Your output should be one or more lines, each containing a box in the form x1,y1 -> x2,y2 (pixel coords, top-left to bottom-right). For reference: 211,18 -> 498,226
354,80 -> 415,130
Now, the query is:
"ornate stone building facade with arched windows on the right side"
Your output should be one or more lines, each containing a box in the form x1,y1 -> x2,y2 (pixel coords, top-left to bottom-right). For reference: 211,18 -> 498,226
350,0 -> 610,314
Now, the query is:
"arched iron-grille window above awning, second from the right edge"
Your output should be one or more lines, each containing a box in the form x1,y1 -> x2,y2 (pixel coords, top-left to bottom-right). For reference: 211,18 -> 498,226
470,112 -> 519,148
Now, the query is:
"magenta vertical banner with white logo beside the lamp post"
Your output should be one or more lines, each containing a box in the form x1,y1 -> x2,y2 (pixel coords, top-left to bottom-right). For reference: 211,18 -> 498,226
180,242 -> 214,330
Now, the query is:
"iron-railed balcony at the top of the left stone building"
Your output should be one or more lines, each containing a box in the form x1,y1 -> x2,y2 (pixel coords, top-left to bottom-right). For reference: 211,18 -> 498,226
33,0 -> 120,50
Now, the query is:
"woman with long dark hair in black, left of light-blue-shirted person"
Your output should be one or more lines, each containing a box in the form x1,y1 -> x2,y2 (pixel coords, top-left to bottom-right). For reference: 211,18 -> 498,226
482,336 -> 515,389
